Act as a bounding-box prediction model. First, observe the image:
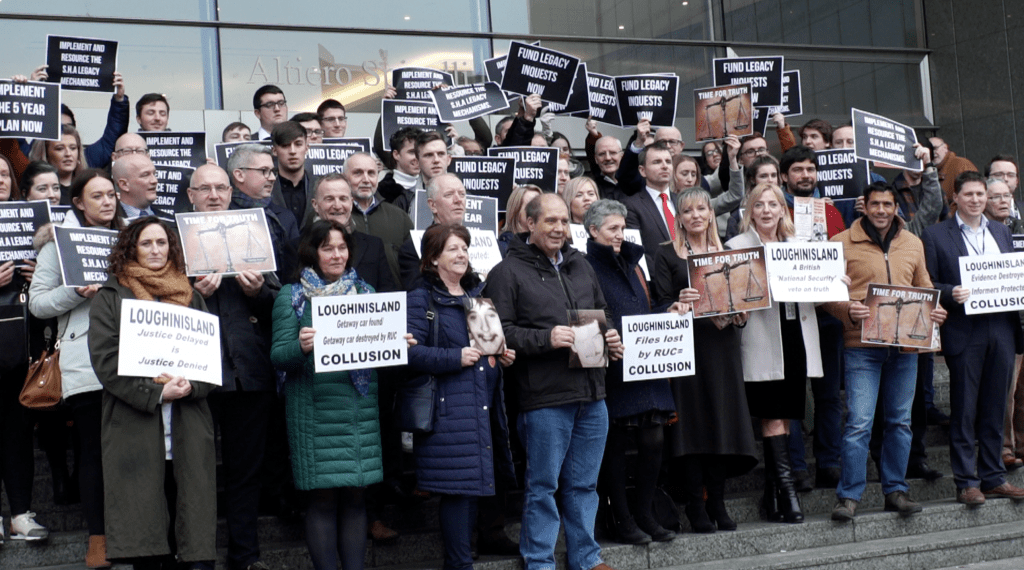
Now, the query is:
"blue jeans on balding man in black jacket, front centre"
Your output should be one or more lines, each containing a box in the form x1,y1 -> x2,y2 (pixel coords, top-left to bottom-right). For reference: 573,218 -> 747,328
518,400 -> 608,570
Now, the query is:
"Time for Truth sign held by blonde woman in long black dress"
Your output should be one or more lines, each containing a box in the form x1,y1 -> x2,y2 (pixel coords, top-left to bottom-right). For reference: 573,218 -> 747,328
686,246 -> 771,318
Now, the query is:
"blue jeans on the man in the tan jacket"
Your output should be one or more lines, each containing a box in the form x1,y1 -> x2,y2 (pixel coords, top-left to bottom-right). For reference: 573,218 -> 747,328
836,347 -> 918,500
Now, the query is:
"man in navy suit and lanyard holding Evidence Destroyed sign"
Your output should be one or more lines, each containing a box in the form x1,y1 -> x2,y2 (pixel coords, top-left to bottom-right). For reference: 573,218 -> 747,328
922,171 -> 1024,506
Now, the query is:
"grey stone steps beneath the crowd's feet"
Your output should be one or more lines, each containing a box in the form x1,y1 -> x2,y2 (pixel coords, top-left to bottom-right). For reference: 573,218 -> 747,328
6,358 -> 1024,570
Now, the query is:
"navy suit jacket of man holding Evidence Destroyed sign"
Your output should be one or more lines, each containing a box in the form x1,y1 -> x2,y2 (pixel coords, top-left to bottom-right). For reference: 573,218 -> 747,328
921,216 -> 1024,356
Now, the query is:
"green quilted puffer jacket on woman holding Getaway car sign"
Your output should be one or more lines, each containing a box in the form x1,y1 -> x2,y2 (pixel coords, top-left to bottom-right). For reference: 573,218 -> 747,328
270,284 -> 384,490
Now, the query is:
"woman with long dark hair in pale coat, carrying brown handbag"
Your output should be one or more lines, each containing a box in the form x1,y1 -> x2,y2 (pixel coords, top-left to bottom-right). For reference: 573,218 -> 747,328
29,168 -> 121,568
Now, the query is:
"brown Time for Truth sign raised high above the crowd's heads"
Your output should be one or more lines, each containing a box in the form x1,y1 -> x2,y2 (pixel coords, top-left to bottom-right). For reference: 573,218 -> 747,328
693,84 -> 754,142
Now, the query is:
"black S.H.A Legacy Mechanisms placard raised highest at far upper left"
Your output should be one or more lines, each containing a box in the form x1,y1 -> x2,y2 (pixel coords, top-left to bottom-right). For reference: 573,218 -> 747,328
46,35 -> 118,93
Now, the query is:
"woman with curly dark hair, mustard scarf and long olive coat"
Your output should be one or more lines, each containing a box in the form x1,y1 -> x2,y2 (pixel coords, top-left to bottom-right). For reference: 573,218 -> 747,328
87,216 -> 217,570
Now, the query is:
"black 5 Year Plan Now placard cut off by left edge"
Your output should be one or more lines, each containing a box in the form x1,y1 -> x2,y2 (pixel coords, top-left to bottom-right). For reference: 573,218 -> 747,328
0,79 -> 60,140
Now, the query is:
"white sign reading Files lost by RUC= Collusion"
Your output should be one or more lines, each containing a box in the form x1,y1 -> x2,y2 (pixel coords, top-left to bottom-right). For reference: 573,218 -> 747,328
623,313 -> 696,382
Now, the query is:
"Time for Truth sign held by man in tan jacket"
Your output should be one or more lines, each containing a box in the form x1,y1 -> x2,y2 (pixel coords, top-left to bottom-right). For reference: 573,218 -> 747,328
860,283 -> 939,350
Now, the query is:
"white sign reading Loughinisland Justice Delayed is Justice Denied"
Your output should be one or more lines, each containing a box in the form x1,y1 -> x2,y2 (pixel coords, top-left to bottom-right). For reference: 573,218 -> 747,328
118,299 -> 222,386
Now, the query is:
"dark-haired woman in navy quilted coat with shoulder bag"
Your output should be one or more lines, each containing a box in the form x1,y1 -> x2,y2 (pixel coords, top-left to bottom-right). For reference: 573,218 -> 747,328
408,225 -> 515,570
